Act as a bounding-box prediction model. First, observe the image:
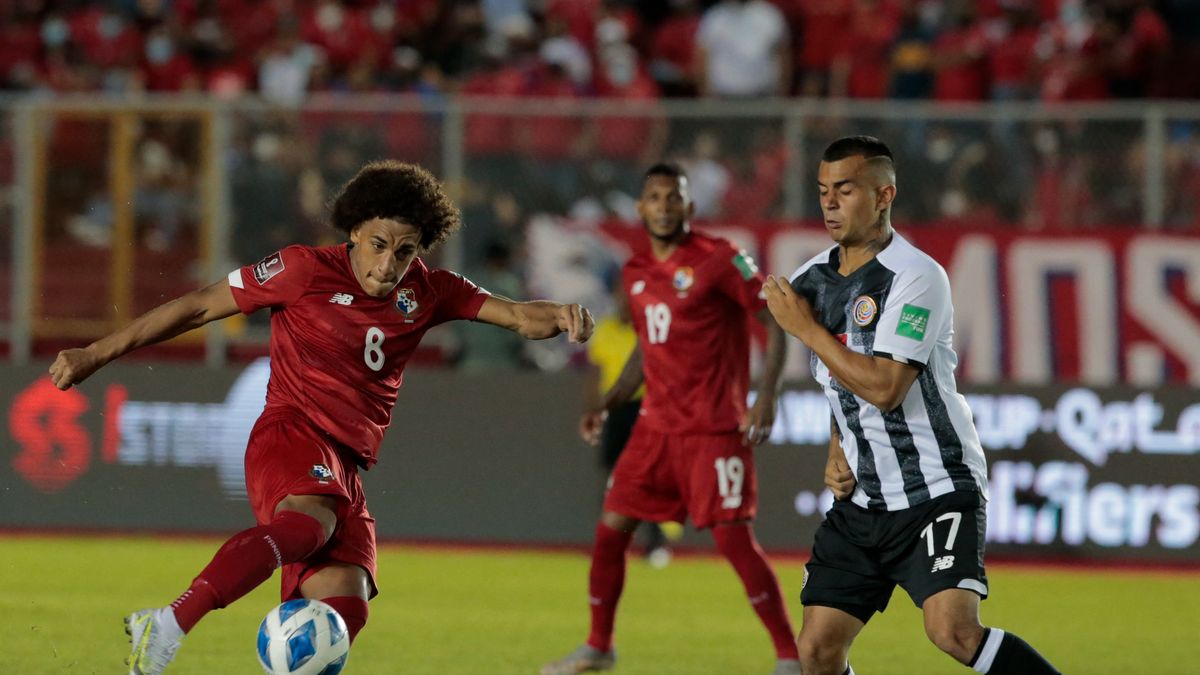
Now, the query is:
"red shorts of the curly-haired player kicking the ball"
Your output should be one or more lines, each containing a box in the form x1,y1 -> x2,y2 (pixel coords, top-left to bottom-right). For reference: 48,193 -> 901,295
246,412 -> 379,601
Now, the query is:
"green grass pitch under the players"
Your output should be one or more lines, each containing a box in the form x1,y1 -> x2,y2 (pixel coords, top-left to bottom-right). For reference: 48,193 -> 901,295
0,536 -> 1200,675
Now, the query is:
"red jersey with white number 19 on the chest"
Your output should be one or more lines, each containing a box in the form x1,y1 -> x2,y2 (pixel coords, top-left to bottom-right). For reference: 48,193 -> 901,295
623,232 -> 767,434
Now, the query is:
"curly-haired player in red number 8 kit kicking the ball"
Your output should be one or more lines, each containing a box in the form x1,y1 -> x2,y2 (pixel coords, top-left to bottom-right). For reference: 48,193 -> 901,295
50,161 -> 592,674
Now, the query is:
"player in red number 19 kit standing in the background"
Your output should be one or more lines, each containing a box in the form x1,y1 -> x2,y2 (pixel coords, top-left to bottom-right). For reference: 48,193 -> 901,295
541,165 -> 800,675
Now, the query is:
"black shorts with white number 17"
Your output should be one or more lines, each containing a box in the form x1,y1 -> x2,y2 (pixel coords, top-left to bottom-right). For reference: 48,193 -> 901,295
800,491 -> 988,622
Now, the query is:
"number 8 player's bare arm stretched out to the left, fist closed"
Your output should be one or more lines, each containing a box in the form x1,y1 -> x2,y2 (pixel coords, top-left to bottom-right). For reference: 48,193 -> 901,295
50,279 -> 239,389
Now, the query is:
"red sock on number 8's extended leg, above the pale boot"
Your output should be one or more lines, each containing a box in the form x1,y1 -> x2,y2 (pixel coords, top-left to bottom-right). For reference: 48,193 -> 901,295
170,510 -> 325,633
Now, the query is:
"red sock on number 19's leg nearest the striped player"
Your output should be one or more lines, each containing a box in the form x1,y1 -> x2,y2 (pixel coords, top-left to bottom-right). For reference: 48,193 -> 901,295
713,522 -> 799,658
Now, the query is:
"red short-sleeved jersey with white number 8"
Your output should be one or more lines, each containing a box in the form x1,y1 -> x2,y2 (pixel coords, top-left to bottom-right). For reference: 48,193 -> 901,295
229,244 -> 488,468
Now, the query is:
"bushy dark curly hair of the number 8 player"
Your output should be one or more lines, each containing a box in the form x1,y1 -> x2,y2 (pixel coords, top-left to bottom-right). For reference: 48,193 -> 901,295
330,160 -> 462,251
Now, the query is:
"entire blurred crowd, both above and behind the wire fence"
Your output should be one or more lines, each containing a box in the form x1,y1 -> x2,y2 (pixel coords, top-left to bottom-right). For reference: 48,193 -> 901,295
0,0 -> 1200,369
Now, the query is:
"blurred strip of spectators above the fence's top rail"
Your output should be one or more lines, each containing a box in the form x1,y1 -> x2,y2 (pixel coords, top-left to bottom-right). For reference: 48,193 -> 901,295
0,0 -> 1200,103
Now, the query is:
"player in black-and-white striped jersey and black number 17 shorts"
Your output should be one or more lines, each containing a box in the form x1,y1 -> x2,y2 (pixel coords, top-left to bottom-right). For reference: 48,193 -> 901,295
764,136 -> 1057,675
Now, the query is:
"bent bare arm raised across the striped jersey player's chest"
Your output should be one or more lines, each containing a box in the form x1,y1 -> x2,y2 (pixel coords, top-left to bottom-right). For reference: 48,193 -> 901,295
763,276 -> 920,412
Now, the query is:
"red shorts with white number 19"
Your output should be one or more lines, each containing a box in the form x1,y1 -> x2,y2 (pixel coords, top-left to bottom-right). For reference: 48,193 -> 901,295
604,422 -> 758,530
